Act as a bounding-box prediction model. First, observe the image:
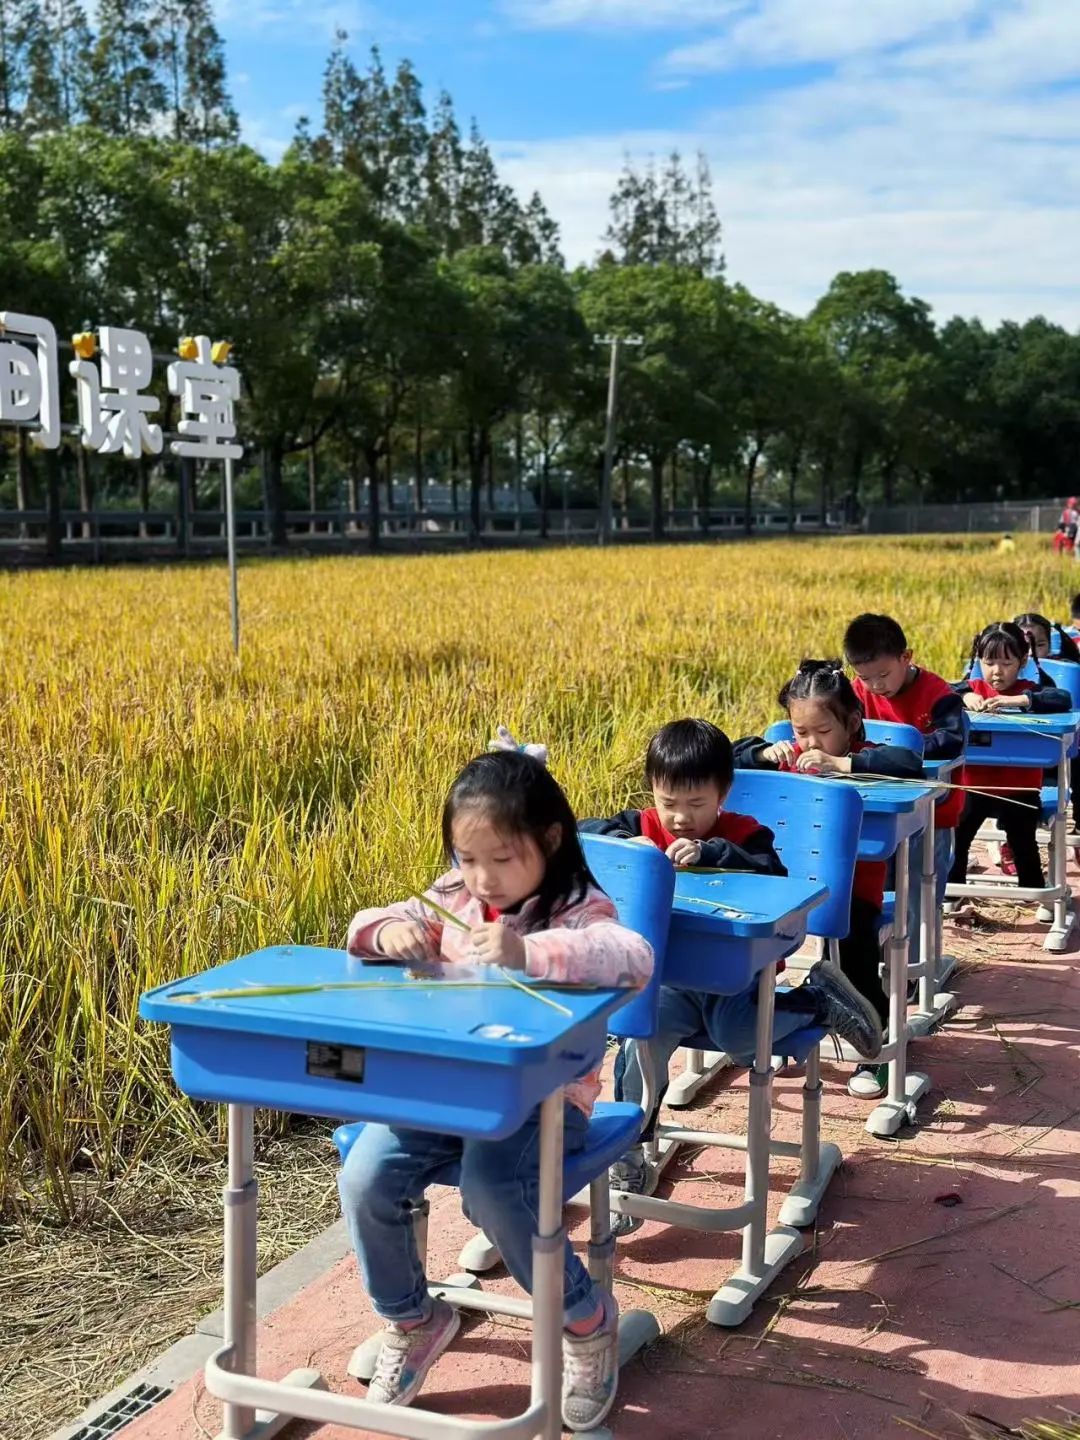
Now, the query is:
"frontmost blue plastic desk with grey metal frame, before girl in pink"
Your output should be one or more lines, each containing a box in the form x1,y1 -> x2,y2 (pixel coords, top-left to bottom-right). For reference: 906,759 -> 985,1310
140,946 -> 632,1440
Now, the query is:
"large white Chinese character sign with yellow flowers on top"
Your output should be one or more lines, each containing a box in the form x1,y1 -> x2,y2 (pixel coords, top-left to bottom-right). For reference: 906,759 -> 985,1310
0,310 -> 243,461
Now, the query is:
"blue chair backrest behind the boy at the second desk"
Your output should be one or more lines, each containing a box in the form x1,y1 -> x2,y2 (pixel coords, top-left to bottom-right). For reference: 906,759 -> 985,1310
724,770 -> 863,940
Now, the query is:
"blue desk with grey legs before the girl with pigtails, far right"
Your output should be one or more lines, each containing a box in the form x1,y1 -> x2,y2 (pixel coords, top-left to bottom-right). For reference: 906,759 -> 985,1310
946,710 -> 1080,953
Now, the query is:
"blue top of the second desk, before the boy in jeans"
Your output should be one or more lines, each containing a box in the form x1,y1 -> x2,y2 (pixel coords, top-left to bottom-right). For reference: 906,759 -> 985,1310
668,870 -> 828,943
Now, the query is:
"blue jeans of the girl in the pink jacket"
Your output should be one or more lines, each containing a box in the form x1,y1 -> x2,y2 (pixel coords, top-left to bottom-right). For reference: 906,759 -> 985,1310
337,1104 -> 599,1325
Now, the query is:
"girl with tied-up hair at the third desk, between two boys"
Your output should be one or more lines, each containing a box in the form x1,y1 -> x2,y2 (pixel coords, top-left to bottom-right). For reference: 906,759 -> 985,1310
734,660 -> 923,1099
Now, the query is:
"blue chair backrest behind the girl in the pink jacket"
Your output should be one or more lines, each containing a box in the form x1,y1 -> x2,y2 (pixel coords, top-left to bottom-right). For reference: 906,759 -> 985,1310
582,835 -> 675,1040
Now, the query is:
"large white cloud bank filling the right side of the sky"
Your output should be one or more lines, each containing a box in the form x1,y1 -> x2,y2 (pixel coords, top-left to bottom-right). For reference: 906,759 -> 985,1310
492,0 -> 1080,328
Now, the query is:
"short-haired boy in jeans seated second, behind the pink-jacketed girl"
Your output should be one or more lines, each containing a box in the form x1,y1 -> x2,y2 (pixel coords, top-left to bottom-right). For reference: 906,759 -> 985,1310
579,720 -> 881,1234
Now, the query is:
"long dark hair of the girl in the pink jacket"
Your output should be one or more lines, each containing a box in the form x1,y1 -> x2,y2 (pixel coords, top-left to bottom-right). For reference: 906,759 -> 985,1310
442,750 -> 599,930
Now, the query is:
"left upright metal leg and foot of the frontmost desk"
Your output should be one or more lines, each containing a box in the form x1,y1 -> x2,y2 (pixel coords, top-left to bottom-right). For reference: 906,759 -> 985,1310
219,1104 -> 325,1440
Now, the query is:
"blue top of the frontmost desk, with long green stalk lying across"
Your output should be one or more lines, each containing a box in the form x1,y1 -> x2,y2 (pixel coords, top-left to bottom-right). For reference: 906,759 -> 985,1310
138,945 -> 634,1066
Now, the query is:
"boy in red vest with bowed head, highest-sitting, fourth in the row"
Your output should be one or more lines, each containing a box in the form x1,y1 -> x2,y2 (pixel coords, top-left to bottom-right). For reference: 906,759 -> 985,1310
844,615 -> 963,965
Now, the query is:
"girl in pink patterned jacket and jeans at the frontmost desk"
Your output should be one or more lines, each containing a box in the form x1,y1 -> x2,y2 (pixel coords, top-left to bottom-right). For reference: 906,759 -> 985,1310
338,750 -> 652,1430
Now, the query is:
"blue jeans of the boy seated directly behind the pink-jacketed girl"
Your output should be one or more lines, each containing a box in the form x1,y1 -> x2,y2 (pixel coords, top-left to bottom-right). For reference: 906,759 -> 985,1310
615,985 -> 816,1159
